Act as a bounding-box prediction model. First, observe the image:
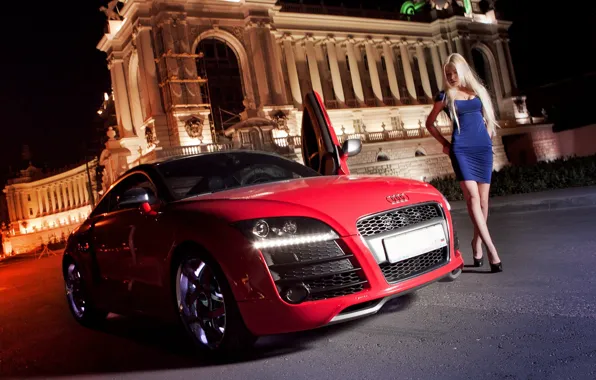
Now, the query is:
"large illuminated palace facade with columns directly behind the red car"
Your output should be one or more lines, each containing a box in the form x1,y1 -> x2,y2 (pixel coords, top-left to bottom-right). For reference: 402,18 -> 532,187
97,0 -> 540,187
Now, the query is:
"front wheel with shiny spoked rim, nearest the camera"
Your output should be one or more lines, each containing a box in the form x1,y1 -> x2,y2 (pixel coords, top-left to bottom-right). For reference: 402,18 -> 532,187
173,250 -> 257,353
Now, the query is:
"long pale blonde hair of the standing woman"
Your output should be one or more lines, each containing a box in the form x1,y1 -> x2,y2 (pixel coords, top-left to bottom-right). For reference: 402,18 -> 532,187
443,53 -> 499,137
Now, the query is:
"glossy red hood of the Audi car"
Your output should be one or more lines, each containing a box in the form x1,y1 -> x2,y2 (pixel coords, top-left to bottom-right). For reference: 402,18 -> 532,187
177,175 -> 443,234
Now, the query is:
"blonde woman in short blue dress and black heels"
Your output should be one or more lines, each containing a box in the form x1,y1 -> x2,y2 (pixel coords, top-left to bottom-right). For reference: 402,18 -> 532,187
426,54 -> 503,272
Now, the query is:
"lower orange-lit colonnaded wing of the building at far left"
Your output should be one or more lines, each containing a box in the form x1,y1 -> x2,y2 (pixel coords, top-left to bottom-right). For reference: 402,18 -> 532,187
2,161 -> 97,254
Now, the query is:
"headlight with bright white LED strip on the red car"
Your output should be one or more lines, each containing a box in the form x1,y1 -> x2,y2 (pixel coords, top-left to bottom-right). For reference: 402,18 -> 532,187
235,217 -> 339,249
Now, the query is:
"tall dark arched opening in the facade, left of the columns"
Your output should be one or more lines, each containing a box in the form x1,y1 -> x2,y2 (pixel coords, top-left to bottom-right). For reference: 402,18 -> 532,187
196,37 -> 244,134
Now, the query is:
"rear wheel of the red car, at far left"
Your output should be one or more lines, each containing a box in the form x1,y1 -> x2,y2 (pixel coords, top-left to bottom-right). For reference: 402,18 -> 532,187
64,260 -> 108,327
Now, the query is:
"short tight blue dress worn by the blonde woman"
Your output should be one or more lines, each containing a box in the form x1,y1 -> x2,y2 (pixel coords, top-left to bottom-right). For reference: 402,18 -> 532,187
435,91 -> 493,183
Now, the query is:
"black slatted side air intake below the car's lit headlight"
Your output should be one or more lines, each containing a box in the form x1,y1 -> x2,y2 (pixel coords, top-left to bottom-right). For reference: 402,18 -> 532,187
262,241 -> 367,301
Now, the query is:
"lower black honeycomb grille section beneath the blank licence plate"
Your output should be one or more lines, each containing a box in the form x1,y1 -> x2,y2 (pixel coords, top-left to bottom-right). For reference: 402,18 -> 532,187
380,247 -> 449,284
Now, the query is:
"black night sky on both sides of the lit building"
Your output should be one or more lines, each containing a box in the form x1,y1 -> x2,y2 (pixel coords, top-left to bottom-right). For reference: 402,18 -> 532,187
0,0 -> 596,184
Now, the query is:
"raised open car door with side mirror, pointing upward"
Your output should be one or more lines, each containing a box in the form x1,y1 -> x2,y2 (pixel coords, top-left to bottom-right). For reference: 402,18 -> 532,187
301,91 -> 362,175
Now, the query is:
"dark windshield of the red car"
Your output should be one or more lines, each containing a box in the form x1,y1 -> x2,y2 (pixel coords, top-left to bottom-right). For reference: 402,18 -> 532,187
157,152 -> 320,199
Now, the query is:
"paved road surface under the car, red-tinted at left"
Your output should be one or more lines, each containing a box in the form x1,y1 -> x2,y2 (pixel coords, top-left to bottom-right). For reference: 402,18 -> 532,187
0,208 -> 596,380
